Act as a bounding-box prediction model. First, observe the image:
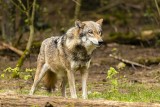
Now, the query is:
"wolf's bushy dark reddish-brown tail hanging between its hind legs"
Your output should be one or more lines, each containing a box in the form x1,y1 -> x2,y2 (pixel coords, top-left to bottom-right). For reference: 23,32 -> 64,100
43,70 -> 57,92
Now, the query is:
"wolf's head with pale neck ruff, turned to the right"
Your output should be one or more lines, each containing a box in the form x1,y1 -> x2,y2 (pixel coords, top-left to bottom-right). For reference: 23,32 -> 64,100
67,19 -> 103,53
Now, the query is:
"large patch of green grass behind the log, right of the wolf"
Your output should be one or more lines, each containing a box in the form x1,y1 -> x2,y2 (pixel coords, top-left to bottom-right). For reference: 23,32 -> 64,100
89,84 -> 160,103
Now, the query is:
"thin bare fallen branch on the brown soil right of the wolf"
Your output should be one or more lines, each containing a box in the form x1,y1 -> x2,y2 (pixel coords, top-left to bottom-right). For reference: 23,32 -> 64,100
109,54 -> 151,69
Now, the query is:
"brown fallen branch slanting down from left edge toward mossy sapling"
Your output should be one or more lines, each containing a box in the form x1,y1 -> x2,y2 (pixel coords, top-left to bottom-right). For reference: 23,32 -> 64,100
0,42 -> 23,56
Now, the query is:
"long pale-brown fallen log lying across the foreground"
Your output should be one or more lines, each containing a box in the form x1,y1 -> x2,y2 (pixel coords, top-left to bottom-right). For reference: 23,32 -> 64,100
0,94 -> 160,107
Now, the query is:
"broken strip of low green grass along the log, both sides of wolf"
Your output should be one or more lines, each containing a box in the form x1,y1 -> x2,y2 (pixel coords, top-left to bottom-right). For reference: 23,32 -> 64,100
0,82 -> 160,103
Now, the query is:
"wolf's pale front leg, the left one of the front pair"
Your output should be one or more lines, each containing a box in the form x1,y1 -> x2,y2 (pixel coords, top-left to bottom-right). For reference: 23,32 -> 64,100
67,70 -> 77,98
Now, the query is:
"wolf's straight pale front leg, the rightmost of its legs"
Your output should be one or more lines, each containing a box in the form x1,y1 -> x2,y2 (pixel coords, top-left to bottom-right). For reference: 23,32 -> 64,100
81,71 -> 88,99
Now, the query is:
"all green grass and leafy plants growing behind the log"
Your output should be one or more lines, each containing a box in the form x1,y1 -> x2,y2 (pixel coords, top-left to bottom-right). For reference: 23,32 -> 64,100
0,67 -> 160,103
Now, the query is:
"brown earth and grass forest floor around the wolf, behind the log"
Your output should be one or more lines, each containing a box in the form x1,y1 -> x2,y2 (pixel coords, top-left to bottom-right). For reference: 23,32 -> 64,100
0,43 -> 160,106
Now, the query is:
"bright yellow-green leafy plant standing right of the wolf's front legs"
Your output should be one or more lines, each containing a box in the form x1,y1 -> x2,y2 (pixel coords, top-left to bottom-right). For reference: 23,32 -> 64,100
106,67 -> 118,92
